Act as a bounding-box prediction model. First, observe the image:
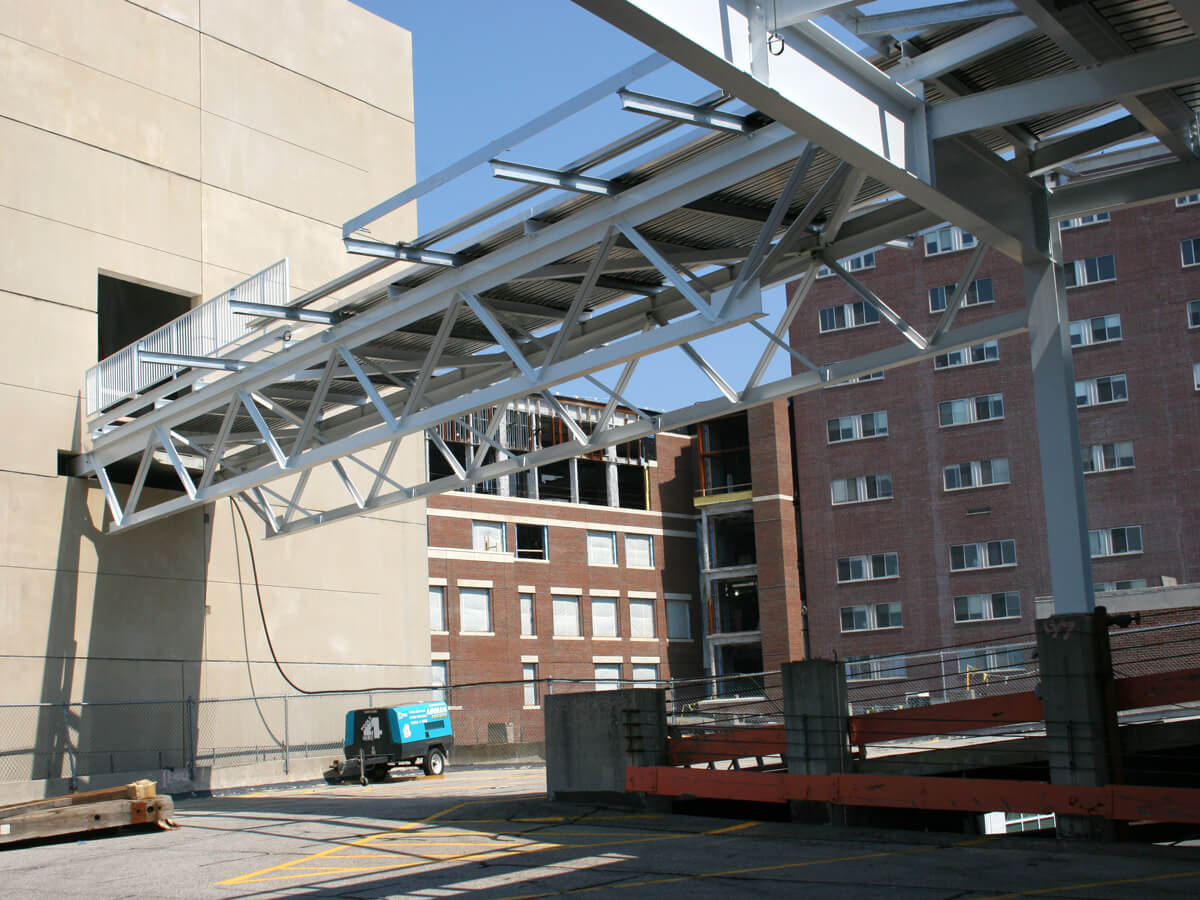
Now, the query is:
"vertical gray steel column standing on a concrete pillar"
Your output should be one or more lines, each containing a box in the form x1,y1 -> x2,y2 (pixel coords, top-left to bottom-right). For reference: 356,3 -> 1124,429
1025,232 -> 1096,614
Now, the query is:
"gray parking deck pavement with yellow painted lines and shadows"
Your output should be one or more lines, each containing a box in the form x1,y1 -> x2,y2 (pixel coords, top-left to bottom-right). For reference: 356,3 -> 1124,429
0,767 -> 1200,900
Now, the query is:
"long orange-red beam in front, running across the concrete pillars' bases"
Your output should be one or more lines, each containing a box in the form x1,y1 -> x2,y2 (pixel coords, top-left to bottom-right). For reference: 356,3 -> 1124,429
625,767 -> 1200,823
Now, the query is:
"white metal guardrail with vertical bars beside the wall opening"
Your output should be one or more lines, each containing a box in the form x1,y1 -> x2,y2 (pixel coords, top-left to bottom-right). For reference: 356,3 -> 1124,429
85,257 -> 289,415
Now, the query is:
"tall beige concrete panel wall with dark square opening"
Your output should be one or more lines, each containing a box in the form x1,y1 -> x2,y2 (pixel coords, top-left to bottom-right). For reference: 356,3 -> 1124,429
0,0 -> 428,788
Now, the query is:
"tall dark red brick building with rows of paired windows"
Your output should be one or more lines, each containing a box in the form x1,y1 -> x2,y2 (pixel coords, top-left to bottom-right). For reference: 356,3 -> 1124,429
791,188 -> 1200,682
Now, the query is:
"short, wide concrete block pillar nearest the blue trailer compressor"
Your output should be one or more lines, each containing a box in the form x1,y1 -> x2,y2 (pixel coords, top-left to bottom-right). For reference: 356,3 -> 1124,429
545,688 -> 667,802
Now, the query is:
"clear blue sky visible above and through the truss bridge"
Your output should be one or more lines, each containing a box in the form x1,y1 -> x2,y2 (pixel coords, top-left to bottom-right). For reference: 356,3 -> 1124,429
355,0 -> 790,409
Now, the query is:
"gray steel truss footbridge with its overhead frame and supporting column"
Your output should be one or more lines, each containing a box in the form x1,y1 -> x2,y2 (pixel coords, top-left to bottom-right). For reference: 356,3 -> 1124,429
76,0 -> 1200,612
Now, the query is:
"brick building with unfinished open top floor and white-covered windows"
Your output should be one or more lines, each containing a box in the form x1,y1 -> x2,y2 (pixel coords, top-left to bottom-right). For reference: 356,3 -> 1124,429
427,397 -> 701,743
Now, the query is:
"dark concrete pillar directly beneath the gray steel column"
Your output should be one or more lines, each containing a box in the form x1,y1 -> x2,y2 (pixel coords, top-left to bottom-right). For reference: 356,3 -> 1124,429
1038,606 -> 1120,839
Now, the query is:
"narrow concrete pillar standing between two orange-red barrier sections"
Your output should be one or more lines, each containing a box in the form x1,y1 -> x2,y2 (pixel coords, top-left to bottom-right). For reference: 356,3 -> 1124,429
782,659 -> 850,824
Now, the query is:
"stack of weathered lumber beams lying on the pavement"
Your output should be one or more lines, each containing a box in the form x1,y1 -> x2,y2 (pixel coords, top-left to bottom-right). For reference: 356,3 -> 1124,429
0,781 -> 175,846
